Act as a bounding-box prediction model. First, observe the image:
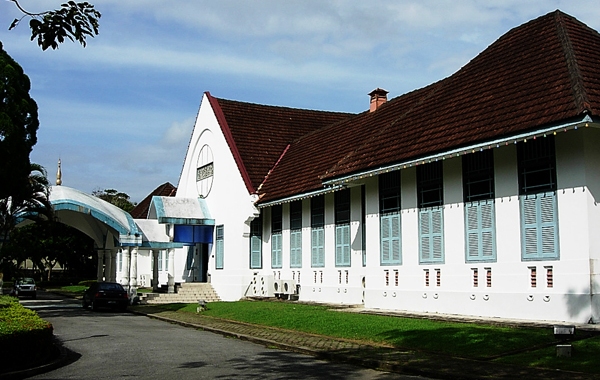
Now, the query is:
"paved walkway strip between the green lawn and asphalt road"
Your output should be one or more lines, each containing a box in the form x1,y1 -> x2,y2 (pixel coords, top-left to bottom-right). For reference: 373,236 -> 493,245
131,305 -> 600,380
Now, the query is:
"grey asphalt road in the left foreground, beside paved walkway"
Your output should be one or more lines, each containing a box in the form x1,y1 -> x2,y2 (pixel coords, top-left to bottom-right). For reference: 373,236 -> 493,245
21,292 -> 423,380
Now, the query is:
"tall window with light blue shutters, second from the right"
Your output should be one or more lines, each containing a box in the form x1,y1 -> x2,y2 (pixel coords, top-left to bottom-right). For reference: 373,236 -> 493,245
462,150 -> 496,262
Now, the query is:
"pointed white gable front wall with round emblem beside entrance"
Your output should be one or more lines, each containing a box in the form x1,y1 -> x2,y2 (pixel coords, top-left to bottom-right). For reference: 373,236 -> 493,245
175,95 -> 258,301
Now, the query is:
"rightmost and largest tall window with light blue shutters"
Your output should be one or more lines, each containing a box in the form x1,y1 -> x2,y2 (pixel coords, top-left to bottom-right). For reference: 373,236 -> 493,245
517,136 -> 559,261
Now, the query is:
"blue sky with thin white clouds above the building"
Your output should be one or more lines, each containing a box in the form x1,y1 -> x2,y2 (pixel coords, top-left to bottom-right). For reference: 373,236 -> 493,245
0,0 -> 600,202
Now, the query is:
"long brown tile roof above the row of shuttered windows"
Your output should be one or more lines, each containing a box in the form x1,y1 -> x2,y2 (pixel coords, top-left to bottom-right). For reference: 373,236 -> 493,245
259,11 -> 600,202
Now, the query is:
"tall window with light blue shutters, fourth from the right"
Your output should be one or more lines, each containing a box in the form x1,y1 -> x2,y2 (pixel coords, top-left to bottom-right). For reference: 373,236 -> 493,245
379,171 -> 402,265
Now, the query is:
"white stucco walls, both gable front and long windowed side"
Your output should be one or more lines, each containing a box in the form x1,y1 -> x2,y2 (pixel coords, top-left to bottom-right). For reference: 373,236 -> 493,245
165,97 -> 600,323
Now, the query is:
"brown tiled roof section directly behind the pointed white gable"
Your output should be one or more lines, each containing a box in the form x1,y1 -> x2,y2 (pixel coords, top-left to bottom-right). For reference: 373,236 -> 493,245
205,92 -> 353,194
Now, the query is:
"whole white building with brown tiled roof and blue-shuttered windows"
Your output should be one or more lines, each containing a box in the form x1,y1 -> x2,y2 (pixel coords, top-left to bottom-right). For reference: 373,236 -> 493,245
119,11 -> 600,323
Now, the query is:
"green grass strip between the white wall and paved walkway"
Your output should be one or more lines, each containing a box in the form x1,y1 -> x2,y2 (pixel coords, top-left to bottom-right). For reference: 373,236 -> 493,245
154,301 -> 564,359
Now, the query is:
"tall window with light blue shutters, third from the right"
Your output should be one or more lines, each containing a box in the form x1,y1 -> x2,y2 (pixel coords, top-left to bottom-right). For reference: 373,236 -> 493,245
417,161 -> 444,264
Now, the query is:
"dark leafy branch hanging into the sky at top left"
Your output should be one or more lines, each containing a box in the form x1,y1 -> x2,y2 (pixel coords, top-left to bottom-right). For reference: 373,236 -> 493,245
8,0 -> 102,50
